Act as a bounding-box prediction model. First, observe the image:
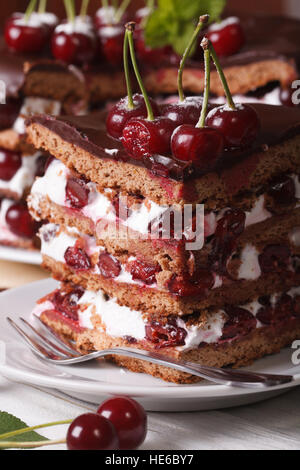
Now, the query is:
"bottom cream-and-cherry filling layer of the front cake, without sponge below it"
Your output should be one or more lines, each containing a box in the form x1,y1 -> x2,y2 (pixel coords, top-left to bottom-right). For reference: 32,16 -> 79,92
34,285 -> 300,350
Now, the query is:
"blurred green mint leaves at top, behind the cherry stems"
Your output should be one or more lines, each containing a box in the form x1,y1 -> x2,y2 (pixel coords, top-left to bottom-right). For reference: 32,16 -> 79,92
145,0 -> 226,55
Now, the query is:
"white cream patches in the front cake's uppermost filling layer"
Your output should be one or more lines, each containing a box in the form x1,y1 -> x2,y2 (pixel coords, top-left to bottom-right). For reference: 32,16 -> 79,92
30,160 -> 292,241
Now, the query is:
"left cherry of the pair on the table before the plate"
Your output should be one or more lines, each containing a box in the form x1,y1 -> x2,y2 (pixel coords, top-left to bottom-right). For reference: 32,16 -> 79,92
67,413 -> 119,450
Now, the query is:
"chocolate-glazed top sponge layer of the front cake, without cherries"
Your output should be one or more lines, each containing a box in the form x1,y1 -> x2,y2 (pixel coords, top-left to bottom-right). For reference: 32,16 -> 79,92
27,104 -> 300,209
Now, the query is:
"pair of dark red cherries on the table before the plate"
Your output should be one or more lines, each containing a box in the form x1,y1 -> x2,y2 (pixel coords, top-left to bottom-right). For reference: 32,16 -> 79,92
67,396 -> 147,450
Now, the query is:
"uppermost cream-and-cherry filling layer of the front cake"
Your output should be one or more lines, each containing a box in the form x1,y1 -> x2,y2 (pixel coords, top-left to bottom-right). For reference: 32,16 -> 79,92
30,160 -> 300,253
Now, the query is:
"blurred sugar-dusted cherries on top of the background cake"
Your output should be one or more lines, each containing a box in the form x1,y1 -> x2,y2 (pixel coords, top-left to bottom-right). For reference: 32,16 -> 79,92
5,0 -> 245,65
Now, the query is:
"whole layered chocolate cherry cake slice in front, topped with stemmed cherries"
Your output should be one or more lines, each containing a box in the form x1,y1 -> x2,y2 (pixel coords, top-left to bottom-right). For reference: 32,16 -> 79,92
27,19 -> 300,383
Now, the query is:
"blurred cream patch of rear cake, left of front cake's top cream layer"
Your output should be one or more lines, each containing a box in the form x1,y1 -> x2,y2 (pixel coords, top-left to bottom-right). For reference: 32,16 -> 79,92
0,152 -> 42,198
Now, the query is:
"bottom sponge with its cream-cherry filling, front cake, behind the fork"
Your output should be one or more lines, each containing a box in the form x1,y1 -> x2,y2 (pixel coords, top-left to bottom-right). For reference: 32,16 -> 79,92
33,283 -> 300,383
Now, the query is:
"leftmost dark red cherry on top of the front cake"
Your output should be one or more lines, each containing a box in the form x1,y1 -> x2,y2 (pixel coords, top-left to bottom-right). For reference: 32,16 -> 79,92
106,94 -> 159,139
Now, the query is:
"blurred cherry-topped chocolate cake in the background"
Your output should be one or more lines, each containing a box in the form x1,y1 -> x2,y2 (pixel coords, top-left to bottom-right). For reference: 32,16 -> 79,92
0,1 -> 300,250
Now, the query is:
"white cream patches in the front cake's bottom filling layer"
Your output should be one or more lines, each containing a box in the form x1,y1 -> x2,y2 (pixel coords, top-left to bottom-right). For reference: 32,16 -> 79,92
33,287 -> 300,351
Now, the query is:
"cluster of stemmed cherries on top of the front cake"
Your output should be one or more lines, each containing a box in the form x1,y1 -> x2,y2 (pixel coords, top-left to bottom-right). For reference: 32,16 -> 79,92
106,15 -> 260,173
